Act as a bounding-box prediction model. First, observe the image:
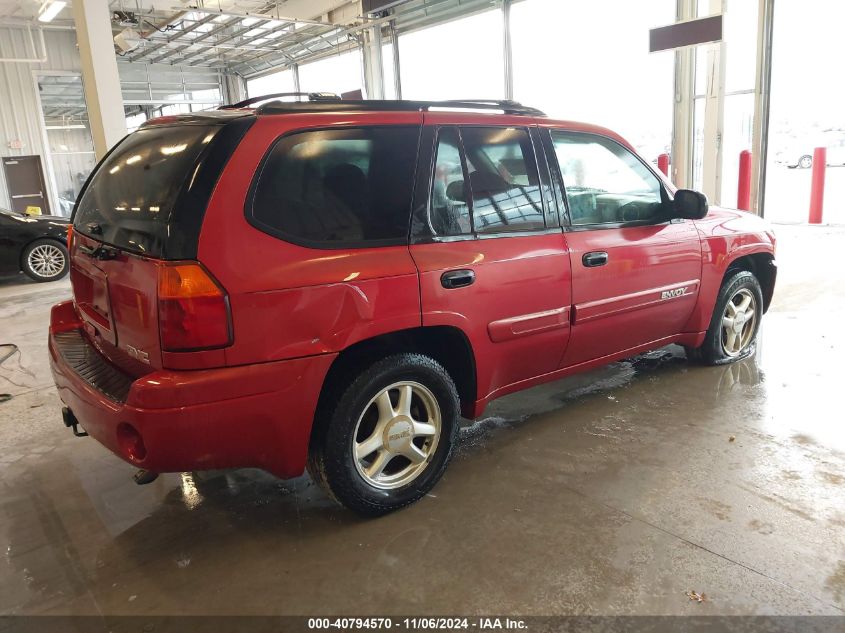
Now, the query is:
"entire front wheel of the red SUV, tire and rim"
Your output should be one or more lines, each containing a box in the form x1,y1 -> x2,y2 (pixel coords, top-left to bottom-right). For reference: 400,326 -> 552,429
687,270 -> 763,365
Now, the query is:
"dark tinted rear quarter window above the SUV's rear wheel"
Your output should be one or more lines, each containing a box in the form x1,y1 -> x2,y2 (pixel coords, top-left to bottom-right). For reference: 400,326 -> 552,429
252,127 -> 419,245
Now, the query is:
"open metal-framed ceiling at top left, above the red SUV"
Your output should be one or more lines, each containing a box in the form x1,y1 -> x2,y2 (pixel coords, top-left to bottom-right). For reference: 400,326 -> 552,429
0,0 -> 512,77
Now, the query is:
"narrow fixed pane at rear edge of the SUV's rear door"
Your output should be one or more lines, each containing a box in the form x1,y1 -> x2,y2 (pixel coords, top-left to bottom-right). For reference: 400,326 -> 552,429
429,128 -> 472,235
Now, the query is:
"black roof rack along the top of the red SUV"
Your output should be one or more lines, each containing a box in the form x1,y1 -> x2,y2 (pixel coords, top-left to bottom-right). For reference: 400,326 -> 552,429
254,98 -> 546,116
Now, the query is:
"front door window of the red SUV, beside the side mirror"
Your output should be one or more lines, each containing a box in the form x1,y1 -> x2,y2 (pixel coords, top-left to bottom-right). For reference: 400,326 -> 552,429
552,131 -> 664,226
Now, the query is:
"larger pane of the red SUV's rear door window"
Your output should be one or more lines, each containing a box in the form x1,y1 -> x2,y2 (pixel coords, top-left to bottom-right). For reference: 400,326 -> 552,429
461,127 -> 545,233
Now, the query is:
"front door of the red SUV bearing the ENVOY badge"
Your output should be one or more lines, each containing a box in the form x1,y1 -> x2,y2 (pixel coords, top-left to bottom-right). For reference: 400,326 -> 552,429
550,130 -> 701,366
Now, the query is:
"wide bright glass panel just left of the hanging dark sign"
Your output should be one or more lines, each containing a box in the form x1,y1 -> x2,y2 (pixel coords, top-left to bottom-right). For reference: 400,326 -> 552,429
508,0 -> 675,161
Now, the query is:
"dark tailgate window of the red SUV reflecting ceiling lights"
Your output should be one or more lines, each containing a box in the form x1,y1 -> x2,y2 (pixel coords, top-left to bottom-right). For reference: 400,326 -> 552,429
74,125 -> 221,257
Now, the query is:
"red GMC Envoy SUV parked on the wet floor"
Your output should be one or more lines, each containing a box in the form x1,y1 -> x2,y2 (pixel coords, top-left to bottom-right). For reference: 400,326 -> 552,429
50,95 -> 776,515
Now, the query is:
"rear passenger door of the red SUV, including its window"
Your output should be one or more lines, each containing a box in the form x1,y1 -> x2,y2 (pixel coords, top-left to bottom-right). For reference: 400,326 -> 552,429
410,113 -> 571,399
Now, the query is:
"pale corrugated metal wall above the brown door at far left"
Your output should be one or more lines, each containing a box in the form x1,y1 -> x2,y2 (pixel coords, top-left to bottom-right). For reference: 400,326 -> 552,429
0,27 -> 81,208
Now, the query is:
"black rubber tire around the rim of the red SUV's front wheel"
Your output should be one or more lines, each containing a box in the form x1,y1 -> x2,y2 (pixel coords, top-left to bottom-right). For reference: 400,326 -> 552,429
685,270 -> 763,365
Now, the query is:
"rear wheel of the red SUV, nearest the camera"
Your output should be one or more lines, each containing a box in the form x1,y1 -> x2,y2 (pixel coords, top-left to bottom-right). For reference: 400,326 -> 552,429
308,354 -> 460,516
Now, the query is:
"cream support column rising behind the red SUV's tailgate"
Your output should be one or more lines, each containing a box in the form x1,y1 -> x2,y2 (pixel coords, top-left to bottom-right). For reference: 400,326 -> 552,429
73,0 -> 126,159
